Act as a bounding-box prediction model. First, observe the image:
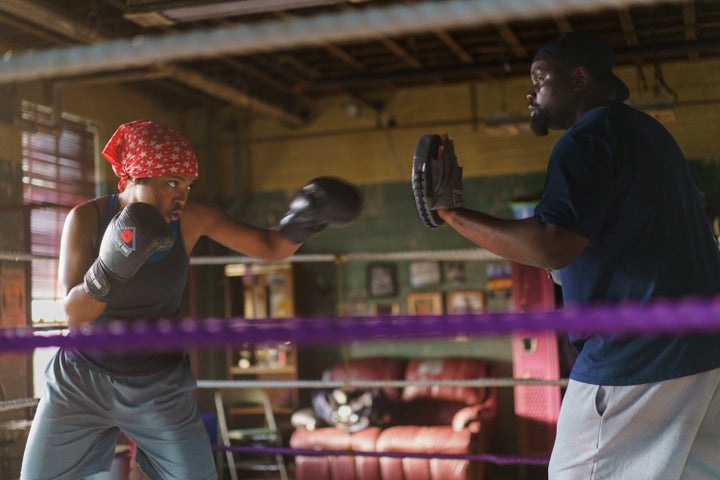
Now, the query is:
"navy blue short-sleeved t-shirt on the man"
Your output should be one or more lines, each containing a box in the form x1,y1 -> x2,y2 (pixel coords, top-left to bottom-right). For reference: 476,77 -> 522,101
535,103 -> 720,385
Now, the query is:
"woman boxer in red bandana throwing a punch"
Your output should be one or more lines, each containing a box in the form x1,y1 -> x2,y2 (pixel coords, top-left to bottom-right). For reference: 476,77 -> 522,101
21,120 -> 360,480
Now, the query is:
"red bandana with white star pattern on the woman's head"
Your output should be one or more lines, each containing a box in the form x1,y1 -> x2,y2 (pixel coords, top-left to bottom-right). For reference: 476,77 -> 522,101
102,120 -> 198,192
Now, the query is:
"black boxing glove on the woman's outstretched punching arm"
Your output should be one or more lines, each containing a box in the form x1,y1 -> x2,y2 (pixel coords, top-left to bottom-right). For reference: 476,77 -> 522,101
278,177 -> 362,243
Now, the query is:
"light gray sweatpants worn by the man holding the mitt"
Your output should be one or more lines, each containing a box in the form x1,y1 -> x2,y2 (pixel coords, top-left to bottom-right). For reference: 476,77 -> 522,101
549,369 -> 720,480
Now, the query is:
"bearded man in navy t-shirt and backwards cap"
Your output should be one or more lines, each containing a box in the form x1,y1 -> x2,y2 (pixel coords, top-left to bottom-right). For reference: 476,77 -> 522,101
424,32 -> 720,480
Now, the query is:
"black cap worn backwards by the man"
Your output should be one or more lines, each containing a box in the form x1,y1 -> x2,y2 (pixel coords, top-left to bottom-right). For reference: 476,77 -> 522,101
533,32 -> 630,102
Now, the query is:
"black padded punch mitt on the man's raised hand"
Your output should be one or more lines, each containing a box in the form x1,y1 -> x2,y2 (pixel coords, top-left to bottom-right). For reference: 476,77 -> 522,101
412,135 -> 464,228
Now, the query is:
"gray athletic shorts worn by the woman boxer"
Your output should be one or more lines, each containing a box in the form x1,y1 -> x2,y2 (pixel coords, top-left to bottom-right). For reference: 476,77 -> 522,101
20,350 -> 217,480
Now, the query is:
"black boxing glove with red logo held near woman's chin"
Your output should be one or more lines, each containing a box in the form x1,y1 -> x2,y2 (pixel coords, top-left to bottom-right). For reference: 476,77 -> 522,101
84,203 -> 174,302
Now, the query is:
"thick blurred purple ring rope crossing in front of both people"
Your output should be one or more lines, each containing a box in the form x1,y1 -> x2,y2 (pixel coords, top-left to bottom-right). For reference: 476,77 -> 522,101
0,297 -> 720,353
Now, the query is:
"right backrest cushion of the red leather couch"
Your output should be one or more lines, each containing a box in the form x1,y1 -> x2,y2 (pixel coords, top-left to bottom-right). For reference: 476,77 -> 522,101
402,357 -> 487,405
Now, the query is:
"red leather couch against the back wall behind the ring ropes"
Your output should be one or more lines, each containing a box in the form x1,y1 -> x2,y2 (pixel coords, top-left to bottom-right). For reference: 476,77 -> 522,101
290,357 -> 497,480
